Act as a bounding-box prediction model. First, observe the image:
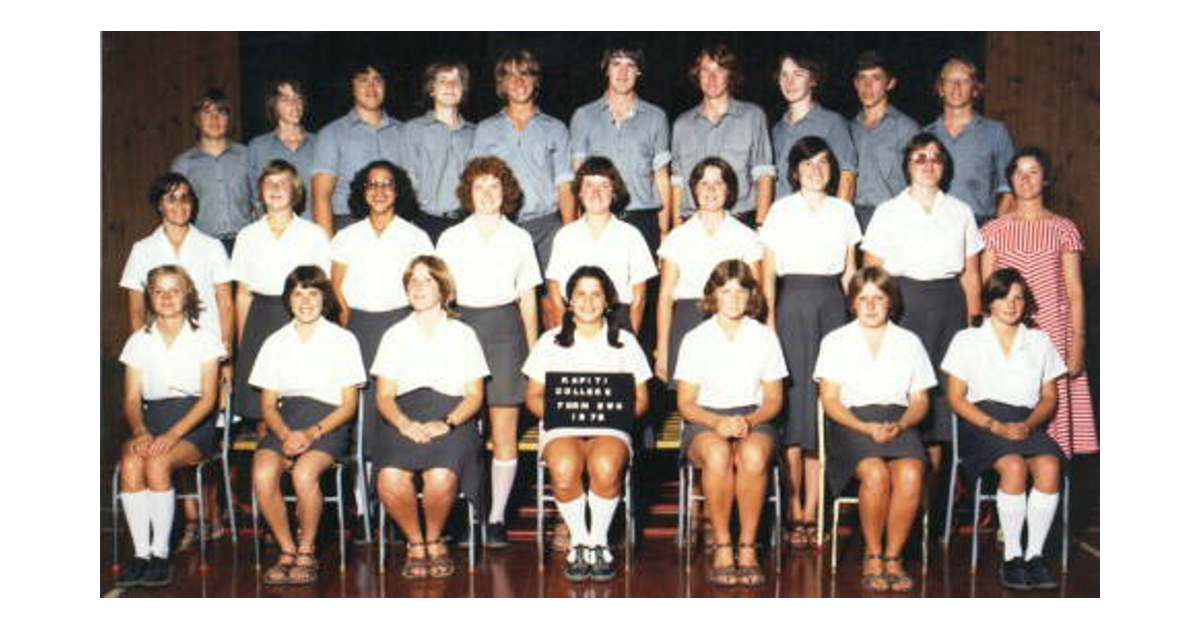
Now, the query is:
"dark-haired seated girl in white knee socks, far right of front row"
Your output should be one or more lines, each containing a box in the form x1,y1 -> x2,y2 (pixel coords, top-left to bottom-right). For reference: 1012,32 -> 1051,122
942,268 -> 1067,590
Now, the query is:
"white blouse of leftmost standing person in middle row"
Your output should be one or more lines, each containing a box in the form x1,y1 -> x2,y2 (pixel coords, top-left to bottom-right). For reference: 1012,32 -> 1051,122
121,226 -> 233,335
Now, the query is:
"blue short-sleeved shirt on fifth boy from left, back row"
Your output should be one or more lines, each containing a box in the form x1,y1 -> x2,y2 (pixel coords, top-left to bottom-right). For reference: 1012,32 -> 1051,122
470,110 -> 571,222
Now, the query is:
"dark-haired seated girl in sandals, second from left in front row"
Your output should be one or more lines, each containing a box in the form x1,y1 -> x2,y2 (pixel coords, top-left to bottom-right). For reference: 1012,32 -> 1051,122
250,265 -> 366,584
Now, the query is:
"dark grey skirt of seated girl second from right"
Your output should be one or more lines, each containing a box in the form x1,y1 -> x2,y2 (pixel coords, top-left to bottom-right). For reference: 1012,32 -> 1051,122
826,404 -> 926,497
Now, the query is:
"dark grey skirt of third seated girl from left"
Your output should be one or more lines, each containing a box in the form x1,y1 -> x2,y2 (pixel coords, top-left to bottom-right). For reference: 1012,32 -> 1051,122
372,388 -> 480,499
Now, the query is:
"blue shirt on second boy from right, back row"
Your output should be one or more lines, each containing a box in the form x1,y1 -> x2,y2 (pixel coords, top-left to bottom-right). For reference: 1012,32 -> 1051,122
850,106 -> 920,208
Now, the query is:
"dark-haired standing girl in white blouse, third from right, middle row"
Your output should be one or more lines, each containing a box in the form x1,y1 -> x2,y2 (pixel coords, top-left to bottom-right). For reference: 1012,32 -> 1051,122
758,136 -> 863,547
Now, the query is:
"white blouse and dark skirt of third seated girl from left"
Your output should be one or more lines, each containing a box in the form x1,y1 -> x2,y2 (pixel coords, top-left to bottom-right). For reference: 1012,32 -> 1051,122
371,313 -> 488,497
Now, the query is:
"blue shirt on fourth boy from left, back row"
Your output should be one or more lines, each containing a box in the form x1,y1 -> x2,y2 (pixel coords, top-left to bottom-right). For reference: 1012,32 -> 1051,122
400,110 -> 475,216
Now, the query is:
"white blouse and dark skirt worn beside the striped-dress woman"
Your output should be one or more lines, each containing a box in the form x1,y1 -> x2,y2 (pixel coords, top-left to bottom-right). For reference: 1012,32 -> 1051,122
863,188 -> 984,442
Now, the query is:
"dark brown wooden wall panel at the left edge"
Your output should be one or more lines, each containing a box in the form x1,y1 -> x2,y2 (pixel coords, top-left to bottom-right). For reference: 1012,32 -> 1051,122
100,32 -> 241,464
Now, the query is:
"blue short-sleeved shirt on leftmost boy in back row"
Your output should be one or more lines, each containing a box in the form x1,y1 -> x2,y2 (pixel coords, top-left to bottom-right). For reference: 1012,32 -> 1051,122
170,142 -> 252,239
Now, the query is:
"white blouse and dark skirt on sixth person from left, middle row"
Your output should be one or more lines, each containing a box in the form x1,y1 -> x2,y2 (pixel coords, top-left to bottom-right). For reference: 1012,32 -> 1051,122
659,212 -> 762,386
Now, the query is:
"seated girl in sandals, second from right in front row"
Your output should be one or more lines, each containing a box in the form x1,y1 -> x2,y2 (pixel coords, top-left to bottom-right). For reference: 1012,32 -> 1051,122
812,265 -> 937,592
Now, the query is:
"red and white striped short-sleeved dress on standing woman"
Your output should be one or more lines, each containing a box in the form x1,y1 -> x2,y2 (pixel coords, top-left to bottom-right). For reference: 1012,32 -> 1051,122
980,214 -> 1100,457
